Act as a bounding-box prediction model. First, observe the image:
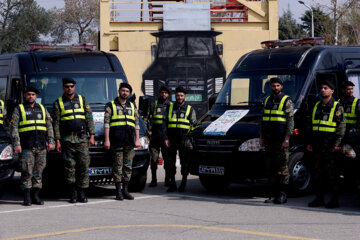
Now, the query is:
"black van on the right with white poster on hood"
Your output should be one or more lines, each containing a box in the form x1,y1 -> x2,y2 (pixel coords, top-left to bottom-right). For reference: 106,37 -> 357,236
188,38 -> 360,192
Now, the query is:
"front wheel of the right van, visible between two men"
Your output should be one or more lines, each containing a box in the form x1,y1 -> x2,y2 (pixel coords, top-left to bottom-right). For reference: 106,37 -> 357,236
288,152 -> 312,195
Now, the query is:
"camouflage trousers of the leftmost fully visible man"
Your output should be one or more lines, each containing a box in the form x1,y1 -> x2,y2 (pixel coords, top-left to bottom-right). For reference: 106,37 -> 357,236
20,148 -> 46,190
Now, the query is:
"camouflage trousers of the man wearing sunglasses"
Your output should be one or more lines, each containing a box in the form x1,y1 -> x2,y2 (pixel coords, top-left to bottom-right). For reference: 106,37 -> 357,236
61,142 -> 90,188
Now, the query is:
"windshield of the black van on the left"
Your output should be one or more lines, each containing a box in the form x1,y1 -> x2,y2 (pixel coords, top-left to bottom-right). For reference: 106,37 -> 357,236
27,73 -> 125,105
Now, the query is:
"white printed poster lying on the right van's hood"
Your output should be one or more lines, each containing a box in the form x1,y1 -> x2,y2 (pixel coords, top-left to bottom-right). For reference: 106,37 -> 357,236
203,110 -> 249,135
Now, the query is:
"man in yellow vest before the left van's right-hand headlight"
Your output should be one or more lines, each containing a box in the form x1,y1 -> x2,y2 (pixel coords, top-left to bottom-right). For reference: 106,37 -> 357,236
104,83 -> 140,201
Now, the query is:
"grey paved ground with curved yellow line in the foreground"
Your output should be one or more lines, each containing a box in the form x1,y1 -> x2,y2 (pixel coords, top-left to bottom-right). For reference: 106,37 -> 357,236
0,169 -> 360,240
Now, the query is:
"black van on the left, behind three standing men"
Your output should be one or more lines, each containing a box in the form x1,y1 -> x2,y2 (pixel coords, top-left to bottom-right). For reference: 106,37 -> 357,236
0,44 -> 150,191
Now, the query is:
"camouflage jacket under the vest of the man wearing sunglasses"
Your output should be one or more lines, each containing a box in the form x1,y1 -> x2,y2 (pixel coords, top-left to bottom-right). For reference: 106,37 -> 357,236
52,95 -> 95,143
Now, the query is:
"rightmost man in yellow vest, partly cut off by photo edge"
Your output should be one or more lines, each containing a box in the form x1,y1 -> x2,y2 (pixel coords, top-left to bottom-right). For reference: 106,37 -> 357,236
339,81 -> 360,142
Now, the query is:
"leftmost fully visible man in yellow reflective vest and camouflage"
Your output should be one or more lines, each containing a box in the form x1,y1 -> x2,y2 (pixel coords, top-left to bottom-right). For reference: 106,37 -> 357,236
10,87 -> 55,206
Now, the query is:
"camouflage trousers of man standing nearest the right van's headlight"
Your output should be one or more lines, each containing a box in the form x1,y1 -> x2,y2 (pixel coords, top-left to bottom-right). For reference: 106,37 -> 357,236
264,139 -> 290,188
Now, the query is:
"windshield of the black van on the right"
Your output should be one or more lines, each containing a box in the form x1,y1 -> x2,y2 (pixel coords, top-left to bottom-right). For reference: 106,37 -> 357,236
215,70 -> 307,106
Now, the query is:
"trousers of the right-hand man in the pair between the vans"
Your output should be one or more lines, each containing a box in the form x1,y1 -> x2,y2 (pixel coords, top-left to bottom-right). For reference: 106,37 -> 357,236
167,139 -> 189,176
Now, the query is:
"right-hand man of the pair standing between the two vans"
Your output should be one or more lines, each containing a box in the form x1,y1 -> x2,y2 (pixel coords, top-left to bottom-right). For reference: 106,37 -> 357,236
164,87 -> 196,192
